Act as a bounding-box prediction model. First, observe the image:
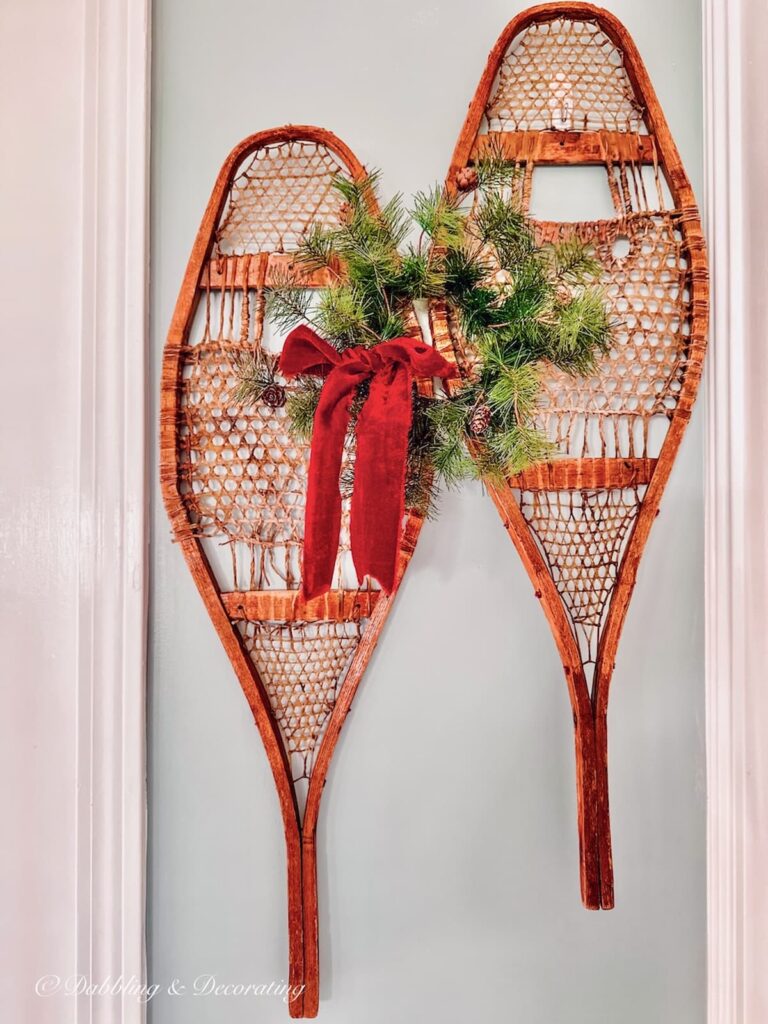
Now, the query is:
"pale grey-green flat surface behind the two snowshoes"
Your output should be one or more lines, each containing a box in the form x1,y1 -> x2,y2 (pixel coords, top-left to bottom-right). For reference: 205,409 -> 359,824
150,0 -> 706,1024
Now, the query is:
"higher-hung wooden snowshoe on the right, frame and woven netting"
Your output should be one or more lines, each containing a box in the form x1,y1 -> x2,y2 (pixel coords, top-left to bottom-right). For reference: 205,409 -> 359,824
432,3 -> 708,909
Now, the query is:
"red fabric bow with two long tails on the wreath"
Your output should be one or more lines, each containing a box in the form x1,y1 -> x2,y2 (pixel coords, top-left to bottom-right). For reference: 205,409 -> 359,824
280,326 -> 456,598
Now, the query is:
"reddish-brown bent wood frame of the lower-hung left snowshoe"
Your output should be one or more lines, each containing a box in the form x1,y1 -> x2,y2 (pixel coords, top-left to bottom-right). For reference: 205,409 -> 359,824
160,125 -> 423,1017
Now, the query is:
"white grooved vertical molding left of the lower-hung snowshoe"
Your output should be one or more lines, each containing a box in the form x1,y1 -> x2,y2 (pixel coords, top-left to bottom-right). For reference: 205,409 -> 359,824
76,0 -> 150,1024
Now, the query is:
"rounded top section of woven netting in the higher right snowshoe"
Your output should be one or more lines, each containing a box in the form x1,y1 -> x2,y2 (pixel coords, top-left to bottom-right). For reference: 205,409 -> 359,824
486,19 -> 642,132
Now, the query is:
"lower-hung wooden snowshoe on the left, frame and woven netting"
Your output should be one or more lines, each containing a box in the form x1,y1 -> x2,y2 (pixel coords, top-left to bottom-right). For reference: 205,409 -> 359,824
161,126 -> 422,1017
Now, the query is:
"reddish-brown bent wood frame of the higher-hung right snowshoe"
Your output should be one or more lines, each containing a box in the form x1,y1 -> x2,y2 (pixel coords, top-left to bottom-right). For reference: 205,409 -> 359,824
441,2 -> 709,909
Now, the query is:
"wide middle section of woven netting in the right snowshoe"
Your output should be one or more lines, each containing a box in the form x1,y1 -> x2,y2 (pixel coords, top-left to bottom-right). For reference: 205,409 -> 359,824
537,212 -> 691,458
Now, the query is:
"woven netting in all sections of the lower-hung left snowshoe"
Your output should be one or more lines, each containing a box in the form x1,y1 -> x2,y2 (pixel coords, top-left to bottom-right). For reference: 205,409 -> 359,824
177,141 -> 366,779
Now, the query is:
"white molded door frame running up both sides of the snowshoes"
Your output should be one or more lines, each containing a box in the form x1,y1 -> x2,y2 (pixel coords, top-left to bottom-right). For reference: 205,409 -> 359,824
77,0 -> 768,1024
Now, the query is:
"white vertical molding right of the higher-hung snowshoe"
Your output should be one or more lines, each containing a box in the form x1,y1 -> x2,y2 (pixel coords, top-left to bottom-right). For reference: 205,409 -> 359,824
703,0 -> 768,1024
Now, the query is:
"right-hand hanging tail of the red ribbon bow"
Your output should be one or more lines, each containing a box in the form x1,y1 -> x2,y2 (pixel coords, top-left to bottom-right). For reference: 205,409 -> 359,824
350,364 -> 413,594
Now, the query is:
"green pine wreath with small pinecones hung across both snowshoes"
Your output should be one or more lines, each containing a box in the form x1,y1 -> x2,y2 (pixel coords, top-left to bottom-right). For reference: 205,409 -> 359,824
237,153 -> 611,514
